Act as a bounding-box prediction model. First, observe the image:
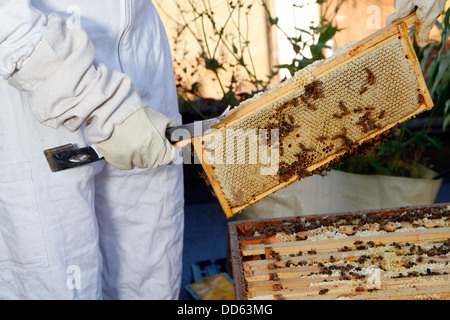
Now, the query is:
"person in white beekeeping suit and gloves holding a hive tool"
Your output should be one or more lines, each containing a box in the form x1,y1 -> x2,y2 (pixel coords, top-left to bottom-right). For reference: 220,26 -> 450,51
0,0 -> 184,299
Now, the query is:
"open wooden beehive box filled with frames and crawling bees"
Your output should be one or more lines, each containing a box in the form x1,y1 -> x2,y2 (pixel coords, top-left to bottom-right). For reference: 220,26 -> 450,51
229,204 -> 450,300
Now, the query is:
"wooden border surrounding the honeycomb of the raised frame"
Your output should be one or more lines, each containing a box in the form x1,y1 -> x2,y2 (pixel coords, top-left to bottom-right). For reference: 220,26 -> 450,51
193,13 -> 433,218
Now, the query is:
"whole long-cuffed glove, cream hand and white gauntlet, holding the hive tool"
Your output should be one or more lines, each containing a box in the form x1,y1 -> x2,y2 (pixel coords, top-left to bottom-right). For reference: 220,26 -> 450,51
8,14 -> 176,169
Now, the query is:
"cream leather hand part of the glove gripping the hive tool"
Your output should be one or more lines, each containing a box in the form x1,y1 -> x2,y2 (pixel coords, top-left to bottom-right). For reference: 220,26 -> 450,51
96,107 -> 177,170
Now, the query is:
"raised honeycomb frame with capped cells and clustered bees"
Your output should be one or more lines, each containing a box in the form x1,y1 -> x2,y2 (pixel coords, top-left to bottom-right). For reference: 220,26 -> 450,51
194,16 -> 430,216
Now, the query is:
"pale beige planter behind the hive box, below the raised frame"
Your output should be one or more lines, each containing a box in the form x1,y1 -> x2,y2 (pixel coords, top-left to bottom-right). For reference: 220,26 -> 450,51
235,168 -> 443,220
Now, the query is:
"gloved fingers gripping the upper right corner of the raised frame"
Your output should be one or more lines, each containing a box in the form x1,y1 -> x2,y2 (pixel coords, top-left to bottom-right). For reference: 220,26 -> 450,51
386,0 -> 446,48
